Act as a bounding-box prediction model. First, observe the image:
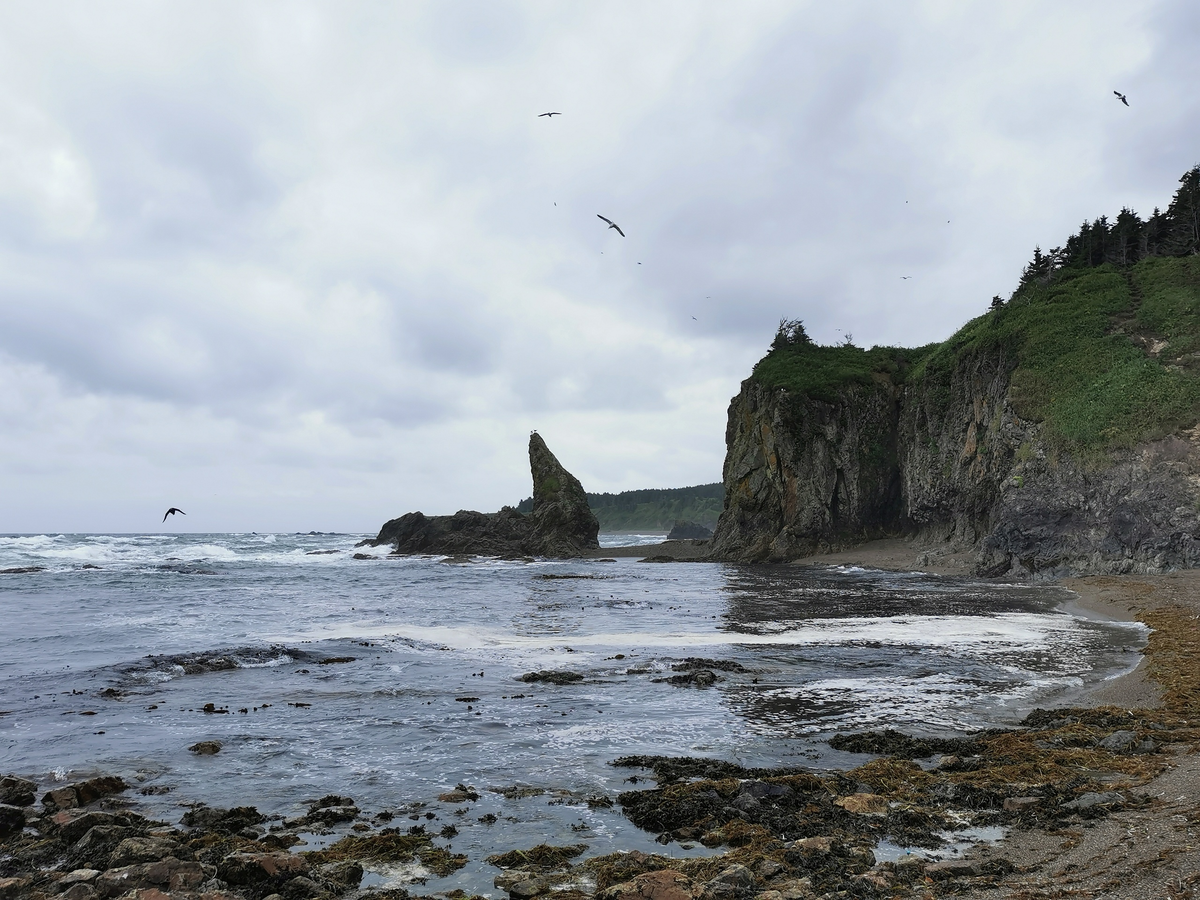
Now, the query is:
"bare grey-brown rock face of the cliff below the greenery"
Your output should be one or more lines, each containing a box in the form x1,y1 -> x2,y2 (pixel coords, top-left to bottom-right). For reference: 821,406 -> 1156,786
713,349 -> 1200,577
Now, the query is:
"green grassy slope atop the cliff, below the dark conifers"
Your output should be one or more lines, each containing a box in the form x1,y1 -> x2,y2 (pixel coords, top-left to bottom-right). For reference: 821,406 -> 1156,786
751,256 -> 1200,449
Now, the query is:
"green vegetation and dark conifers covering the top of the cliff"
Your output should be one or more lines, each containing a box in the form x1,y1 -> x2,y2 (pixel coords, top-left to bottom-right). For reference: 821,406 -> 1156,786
751,166 -> 1200,452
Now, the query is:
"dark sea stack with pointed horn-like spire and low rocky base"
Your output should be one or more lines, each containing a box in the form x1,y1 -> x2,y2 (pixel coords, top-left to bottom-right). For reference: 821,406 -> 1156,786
368,432 -> 600,559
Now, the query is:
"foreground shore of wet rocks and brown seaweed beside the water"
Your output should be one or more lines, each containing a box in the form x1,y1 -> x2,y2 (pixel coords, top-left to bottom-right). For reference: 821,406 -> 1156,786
0,560 -> 1200,900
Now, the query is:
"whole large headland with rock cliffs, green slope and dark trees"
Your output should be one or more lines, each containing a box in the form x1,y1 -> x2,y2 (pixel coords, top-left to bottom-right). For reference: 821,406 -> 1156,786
712,167 -> 1200,578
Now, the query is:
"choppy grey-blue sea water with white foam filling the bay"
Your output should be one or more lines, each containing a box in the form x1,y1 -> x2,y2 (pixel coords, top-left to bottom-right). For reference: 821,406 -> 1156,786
0,534 -> 1145,893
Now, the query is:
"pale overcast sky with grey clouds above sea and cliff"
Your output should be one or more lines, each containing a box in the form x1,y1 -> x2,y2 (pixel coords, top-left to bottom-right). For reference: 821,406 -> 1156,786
0,0 -> 1200,532
